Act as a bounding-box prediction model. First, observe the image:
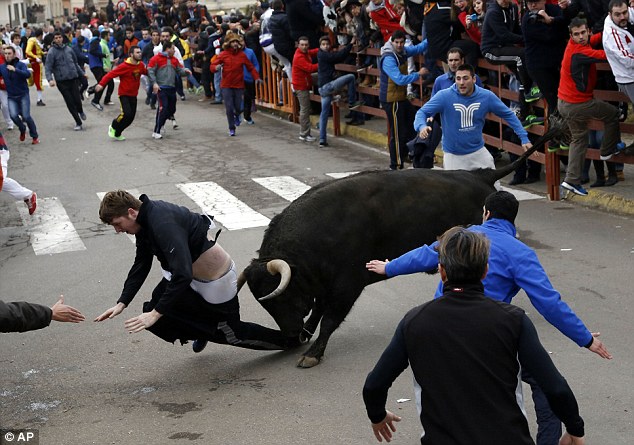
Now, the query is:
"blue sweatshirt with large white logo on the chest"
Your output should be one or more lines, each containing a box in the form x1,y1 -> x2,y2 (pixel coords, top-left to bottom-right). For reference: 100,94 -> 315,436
414,85 -> 529,155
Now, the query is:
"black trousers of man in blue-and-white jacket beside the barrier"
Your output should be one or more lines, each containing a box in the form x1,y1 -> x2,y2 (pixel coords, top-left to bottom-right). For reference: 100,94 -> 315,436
381,100 -> 416,170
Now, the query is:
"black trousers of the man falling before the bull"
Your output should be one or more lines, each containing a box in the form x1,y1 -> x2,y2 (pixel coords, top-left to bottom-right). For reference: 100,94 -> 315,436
143,279 -> 299,350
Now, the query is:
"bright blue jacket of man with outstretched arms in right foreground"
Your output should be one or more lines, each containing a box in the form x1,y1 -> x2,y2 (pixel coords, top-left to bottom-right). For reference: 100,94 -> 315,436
385,218 -> 593,347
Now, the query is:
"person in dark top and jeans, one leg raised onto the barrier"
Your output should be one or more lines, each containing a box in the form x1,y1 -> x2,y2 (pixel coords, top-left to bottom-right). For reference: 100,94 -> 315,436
317,36 -> 363,147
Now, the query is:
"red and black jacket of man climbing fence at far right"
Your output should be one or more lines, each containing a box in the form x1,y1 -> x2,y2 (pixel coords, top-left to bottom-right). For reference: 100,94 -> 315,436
558,33 -> 607,104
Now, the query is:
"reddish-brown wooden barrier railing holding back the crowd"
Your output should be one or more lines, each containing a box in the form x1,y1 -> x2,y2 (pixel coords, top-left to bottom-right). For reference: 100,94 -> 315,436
251,48 -> 634,201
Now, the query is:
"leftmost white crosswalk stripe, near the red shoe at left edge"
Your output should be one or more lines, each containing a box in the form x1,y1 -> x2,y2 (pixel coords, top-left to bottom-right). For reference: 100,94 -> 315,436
17,198 -> 86,255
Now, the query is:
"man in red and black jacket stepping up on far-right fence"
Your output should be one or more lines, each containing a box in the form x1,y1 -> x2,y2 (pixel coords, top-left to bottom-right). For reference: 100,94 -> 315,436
558,17 -> 625,196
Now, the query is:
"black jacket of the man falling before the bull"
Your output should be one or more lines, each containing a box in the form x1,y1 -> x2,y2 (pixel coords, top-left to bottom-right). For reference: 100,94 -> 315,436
117,195 -> 215,314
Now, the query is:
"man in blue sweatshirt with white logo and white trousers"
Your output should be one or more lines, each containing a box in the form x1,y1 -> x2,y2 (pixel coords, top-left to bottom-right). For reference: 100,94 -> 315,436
414,64 -> 533,189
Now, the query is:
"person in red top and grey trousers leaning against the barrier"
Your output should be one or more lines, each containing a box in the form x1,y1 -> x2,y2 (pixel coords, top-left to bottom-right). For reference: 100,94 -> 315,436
292,36 -> 319,142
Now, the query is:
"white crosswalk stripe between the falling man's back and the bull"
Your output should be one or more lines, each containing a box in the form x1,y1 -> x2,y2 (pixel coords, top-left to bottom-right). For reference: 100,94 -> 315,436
176,182 -> 270,230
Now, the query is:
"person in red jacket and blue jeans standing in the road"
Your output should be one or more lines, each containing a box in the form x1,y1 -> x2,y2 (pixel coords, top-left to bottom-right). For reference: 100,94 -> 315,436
210,32 -> 260,136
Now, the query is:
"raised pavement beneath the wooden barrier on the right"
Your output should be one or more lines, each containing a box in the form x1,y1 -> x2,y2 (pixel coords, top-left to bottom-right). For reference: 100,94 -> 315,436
310,110 -> 634,216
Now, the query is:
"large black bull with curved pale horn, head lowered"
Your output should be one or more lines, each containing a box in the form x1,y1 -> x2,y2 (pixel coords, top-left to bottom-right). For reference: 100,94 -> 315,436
241,129 -> 558,367
